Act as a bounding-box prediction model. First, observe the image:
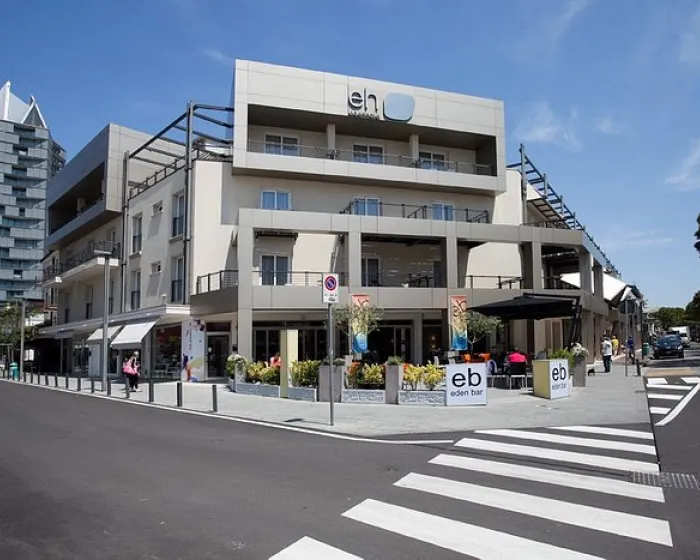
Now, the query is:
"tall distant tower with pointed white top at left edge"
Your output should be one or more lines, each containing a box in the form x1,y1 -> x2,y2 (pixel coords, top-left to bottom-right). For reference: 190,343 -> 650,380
0,81 -> 66,305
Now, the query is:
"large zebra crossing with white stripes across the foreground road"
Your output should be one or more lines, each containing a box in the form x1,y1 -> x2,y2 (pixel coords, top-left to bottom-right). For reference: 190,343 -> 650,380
271,426 -> 676,560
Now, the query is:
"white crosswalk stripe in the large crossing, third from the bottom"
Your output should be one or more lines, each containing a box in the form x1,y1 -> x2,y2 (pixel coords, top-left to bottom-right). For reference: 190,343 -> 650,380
394,473 -> 673,546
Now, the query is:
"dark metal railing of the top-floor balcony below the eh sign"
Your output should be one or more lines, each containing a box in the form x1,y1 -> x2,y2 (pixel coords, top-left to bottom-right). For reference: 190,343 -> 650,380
248,140 -> 496,176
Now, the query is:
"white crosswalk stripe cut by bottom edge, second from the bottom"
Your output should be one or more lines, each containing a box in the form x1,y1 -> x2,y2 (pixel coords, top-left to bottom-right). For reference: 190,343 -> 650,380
343,500 -> 602,560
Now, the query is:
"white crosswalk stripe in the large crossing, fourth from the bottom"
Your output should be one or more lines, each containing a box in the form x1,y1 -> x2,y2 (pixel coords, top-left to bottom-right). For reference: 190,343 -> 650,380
429,453 -> 664,502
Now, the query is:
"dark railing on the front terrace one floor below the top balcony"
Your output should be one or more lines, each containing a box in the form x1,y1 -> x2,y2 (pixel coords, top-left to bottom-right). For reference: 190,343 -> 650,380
340,200 -> 490,224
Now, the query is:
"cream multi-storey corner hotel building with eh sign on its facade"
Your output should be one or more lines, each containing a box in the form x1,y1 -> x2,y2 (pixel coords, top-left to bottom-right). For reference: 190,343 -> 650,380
43,61 -> 628,377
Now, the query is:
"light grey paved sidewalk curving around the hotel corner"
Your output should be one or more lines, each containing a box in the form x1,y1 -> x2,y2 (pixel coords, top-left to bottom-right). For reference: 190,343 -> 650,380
16,363 -> 649,437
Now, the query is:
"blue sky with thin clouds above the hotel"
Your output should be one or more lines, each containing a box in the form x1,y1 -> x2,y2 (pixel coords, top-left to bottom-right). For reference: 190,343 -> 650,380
0,0 -> 700,306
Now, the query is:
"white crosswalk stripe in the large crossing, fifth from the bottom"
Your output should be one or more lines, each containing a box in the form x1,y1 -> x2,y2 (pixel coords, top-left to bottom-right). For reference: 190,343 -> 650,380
455,438 -> 659,472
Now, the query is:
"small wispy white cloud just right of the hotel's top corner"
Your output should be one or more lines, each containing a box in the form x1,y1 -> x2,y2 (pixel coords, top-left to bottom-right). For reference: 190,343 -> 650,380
515,101 -> 581,152
